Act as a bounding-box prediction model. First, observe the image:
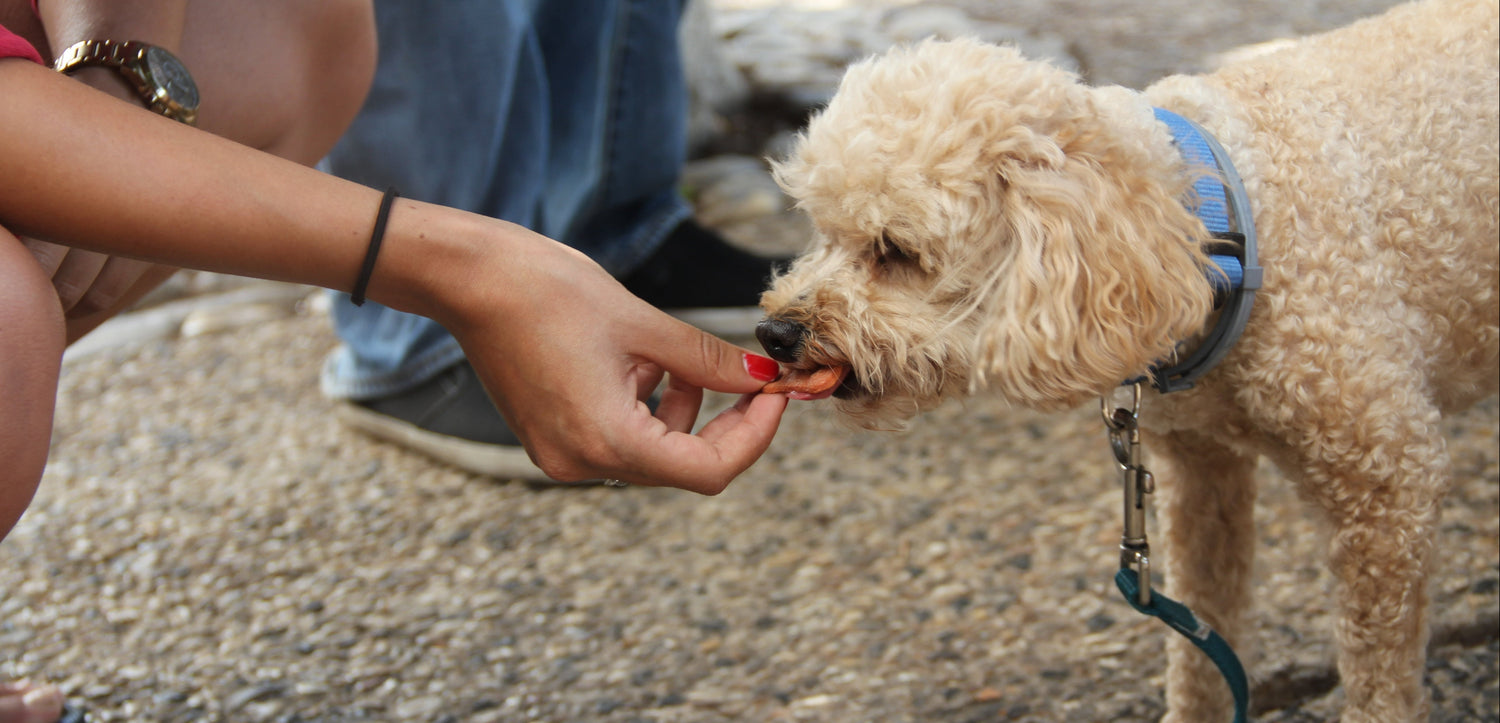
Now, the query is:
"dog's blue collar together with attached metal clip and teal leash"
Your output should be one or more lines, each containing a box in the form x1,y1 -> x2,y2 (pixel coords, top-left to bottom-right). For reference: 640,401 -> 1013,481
1100,108 -> 1263,723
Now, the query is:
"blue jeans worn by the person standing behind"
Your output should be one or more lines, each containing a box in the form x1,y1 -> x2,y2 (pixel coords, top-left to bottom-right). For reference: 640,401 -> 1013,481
321,0 -> 689,399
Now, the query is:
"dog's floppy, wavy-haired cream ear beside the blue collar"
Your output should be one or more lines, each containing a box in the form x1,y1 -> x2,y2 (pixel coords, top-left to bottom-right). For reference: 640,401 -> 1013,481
975,138 -> 1212,410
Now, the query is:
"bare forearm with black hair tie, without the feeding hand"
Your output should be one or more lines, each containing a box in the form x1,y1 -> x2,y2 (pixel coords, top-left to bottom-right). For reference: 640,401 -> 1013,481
0,60 -> 480,324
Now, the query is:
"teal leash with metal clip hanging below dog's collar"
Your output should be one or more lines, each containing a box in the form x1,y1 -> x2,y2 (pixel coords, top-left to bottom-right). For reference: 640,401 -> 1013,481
1100,383 -> 1250,723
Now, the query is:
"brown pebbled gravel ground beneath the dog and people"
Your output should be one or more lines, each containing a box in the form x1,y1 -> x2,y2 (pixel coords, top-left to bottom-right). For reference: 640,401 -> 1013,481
0,0 -> 1500,723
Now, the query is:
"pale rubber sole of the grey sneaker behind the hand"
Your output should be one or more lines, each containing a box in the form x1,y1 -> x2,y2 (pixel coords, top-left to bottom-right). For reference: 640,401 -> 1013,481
335,404 -> 602,486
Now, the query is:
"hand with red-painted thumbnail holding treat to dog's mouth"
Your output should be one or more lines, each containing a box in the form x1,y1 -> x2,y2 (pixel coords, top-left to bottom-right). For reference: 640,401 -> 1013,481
438,217 -> 786,495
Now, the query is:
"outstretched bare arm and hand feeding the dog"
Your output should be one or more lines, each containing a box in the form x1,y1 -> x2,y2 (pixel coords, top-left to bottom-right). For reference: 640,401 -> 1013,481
0,60 -> 786,494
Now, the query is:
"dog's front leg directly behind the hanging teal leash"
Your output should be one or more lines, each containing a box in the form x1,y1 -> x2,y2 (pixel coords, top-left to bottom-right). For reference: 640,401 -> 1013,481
1148,432 -> 1256,723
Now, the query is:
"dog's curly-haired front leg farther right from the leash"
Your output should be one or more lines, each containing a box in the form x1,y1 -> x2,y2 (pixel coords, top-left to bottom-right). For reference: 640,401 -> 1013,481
1283,402 -> 1449,723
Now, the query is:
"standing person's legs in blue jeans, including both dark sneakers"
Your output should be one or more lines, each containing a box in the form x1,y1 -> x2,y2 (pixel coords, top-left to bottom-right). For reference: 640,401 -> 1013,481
323,0 -> 770,482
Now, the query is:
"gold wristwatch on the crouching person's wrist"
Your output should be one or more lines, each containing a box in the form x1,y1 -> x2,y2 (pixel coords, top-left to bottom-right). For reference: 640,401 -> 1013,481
53,41 -> 198,126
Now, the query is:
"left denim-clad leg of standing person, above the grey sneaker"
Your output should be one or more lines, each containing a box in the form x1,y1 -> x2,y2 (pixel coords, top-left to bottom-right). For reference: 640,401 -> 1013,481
323,0 -> 549,399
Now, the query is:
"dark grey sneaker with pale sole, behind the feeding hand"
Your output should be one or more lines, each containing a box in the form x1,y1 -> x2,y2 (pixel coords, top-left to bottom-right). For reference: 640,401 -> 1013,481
335,362 -> 564,485
